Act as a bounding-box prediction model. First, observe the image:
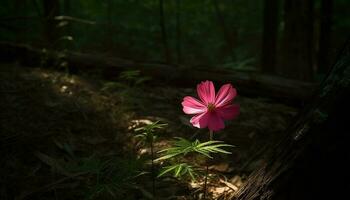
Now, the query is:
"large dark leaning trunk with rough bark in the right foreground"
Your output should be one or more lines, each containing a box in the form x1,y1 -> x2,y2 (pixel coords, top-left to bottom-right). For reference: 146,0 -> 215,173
235,40 -> 350,200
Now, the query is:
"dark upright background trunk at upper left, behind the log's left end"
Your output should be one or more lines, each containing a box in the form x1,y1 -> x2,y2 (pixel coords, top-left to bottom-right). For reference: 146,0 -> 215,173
43,0 -> 59,48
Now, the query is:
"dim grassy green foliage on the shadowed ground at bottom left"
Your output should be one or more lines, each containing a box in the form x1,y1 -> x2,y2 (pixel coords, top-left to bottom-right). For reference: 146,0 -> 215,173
35,146 -> 146,199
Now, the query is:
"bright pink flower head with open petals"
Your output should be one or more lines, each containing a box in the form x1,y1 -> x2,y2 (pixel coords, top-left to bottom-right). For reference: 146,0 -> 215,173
181,81 -> 239,131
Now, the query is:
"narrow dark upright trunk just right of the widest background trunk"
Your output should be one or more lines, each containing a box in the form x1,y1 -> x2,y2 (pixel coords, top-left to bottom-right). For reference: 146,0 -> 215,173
317,0 -> 333,73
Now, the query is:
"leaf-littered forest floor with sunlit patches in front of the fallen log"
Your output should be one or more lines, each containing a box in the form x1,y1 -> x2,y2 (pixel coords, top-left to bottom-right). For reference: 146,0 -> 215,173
0,64 -> 298,200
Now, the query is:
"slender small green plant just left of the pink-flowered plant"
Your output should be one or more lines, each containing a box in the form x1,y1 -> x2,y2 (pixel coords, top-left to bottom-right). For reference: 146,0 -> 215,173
135,121 -> 167,197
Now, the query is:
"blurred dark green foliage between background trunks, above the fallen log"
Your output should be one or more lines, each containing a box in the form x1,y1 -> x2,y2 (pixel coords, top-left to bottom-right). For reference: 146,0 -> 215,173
0,0 -> 262,64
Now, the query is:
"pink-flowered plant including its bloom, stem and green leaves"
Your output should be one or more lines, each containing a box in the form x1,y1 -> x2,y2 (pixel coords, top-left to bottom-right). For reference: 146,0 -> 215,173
179,80 -> 240,199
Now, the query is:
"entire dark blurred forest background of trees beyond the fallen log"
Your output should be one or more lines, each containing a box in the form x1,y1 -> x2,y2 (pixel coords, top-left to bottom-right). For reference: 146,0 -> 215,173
0,0 -> 350,81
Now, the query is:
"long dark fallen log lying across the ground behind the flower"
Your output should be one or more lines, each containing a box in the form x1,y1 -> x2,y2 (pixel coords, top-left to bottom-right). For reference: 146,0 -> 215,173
0,42 -> 317,102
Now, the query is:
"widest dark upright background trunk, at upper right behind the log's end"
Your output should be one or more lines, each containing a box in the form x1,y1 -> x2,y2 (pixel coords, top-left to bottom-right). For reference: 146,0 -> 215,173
279,0 -> 313,80
